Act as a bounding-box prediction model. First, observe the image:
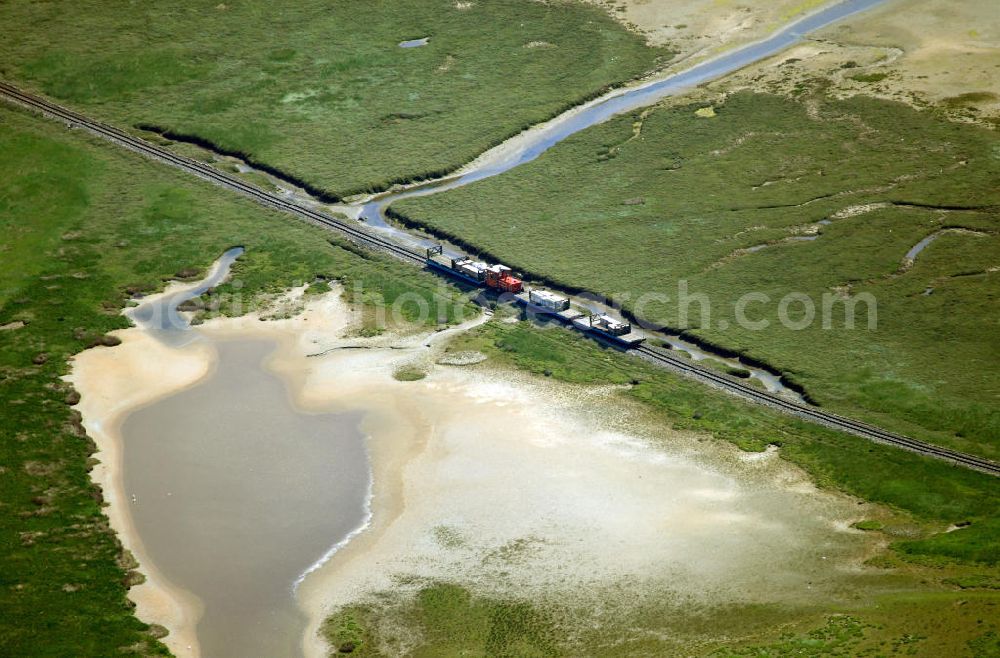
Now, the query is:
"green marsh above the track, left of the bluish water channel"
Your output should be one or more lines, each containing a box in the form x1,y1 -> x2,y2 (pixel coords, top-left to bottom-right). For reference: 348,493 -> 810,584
0,0 -> 666,194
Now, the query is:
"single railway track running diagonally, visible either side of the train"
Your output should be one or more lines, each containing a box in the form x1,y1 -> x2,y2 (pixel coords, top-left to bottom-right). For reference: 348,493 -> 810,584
0,82 -> 1000,476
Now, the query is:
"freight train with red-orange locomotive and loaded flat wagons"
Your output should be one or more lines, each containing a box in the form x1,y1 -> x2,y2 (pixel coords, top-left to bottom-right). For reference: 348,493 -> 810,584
427,245 -> 645,347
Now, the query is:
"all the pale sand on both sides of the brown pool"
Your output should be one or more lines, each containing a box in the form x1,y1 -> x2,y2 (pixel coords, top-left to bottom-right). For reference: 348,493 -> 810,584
71,290 -> 872,656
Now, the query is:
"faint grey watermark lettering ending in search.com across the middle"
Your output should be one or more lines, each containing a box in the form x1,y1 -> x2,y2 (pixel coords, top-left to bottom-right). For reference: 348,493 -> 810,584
130,279 -> 878,332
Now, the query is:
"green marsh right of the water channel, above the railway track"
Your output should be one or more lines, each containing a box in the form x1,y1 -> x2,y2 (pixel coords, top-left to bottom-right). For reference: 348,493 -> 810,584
393,90 -> 1000,459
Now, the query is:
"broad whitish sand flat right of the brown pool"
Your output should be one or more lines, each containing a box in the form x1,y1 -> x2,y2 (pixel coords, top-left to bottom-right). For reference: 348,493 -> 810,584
286,330 -> 874,656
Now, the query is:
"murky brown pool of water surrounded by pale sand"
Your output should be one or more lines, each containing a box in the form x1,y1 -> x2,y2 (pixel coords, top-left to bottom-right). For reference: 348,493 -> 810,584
122,341 -> 371,658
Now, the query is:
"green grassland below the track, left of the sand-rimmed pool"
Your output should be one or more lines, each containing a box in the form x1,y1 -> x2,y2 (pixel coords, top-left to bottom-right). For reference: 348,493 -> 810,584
0,106 -> 474,656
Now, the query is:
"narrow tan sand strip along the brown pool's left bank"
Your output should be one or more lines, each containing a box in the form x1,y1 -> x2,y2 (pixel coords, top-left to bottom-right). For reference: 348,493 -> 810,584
66,283 -> 360,657
